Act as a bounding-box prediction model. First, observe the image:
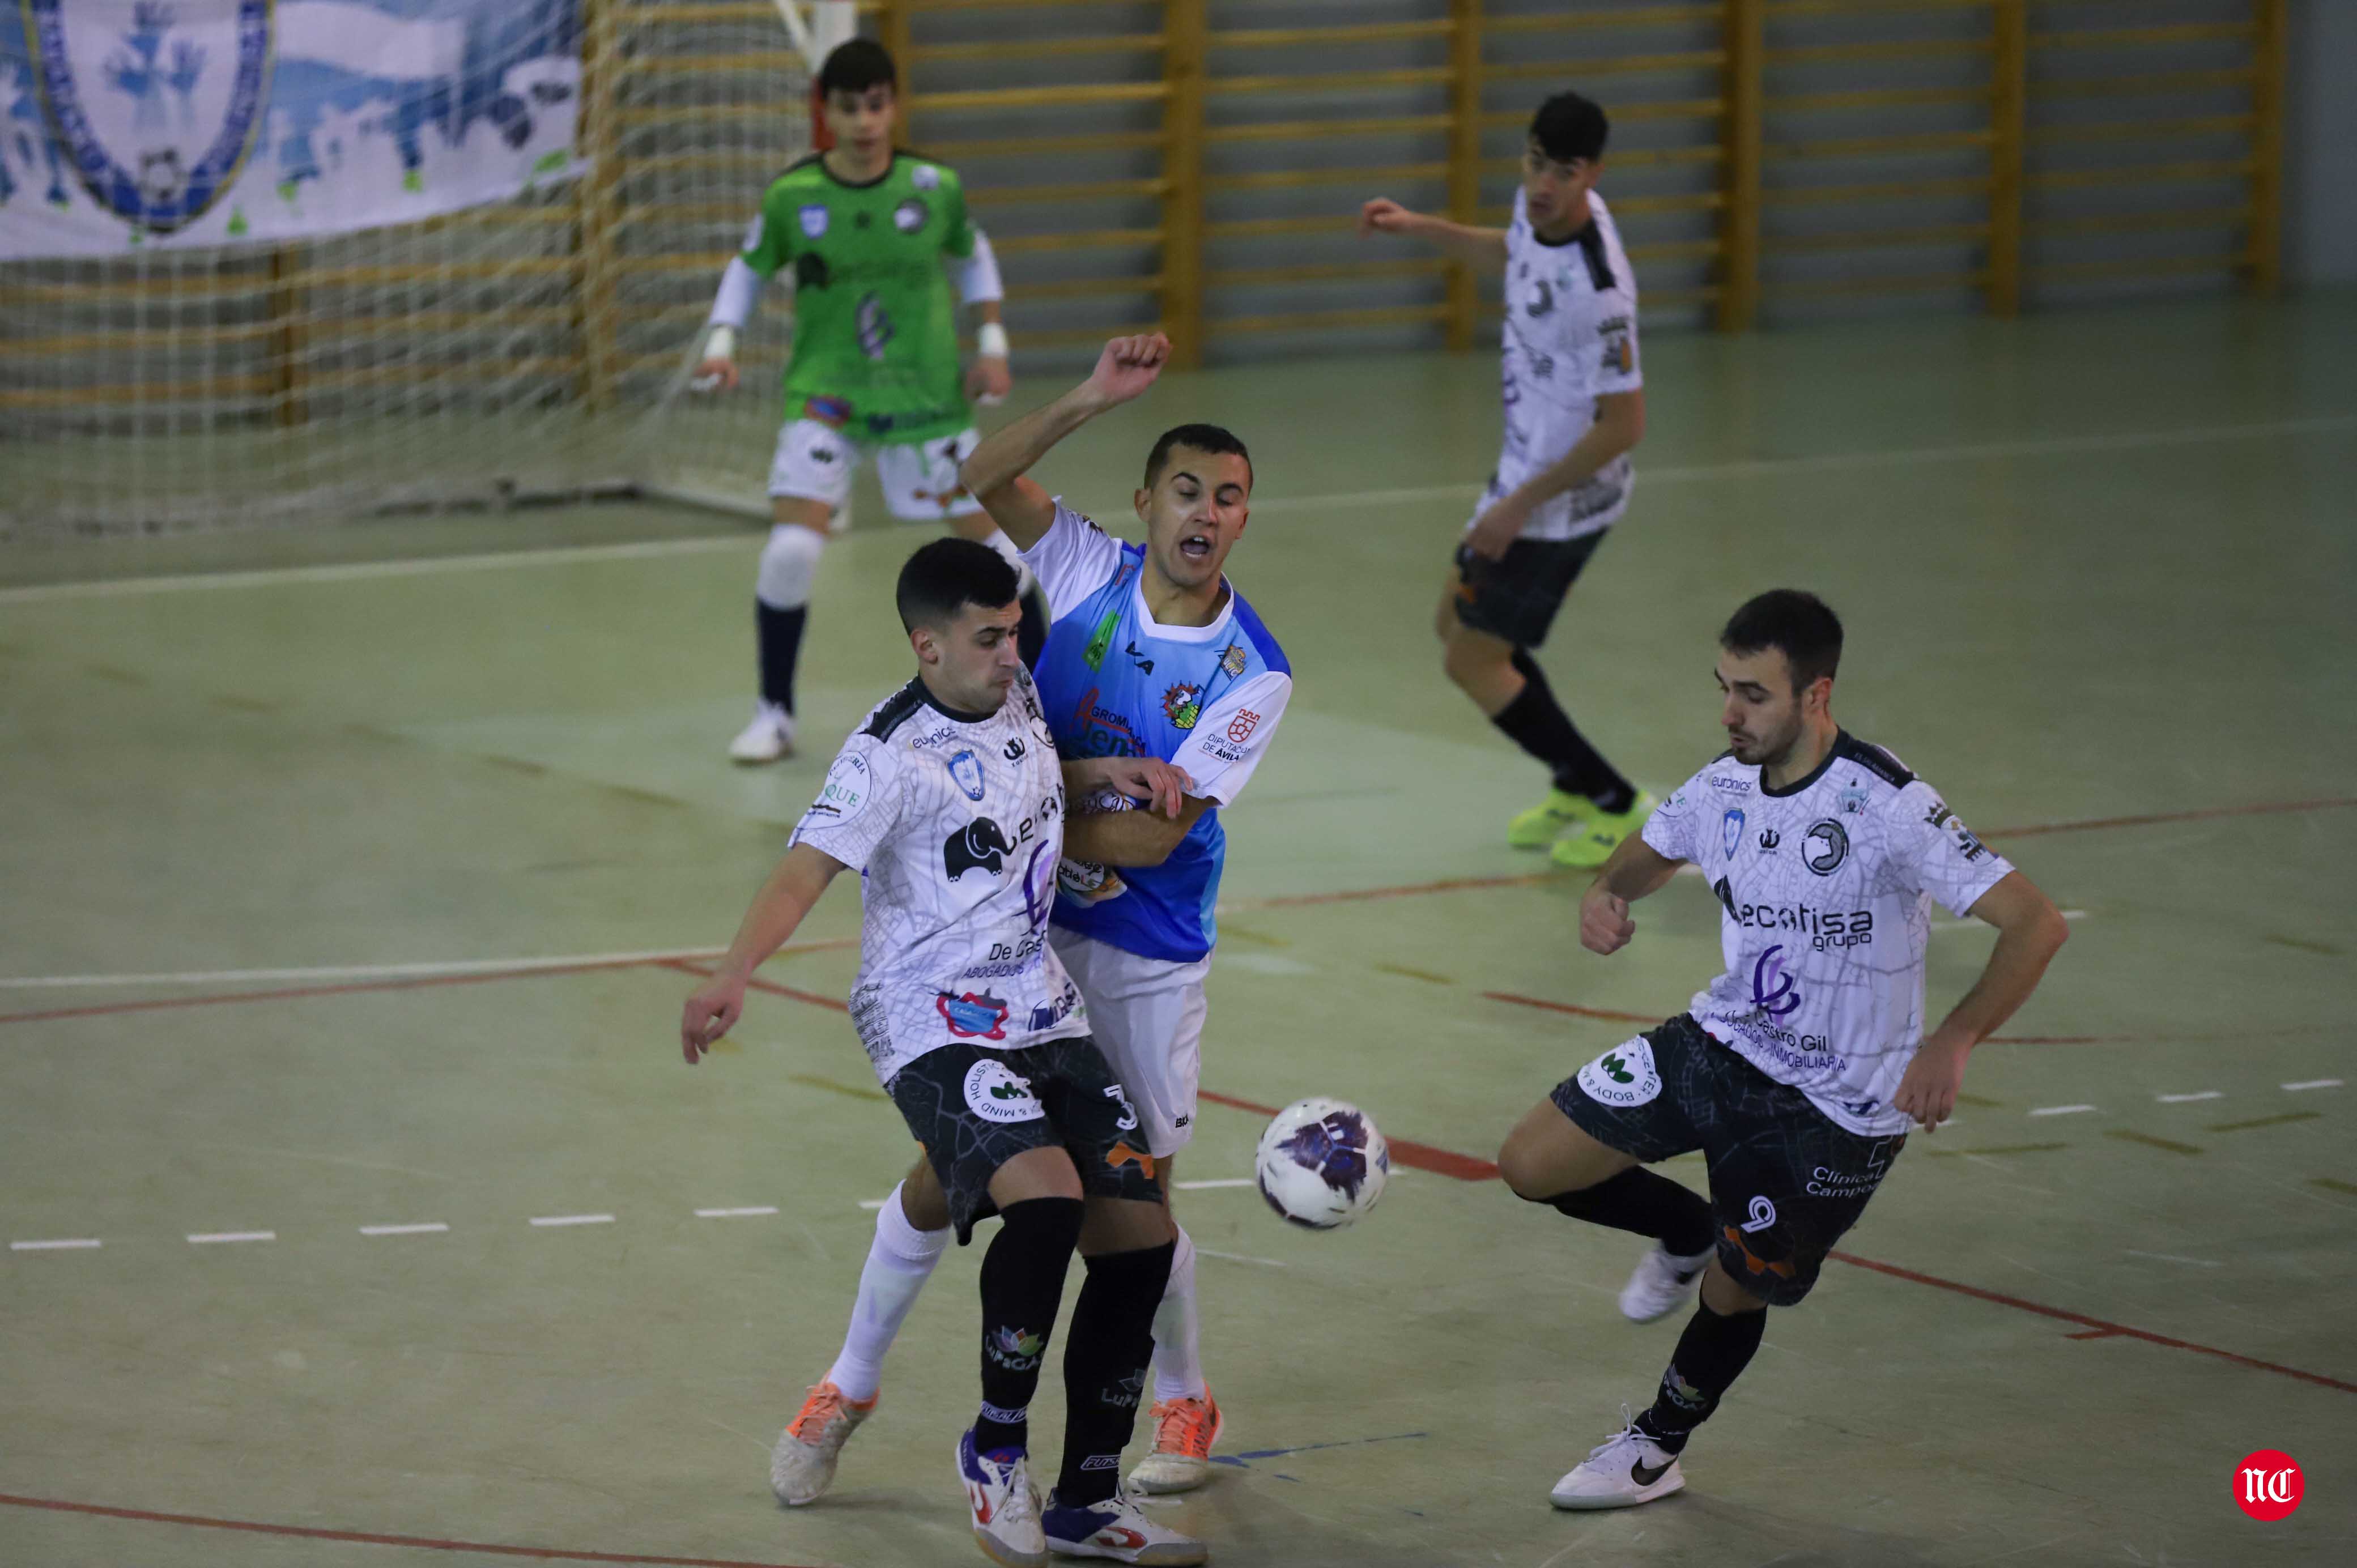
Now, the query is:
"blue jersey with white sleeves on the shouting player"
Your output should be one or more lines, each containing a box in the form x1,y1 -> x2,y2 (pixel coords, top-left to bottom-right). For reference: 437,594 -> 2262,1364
1035,545 -> 1292,962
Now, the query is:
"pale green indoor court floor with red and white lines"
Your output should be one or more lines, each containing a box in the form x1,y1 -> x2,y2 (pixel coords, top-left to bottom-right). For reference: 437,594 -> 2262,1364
14,297 -> 2357,1568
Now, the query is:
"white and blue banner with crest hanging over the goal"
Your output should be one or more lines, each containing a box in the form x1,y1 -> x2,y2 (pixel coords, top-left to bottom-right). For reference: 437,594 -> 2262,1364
0,0 -> 582,259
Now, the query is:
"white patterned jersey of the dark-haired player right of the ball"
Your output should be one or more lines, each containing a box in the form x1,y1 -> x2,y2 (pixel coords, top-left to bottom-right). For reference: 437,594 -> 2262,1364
1645,731 -> 2013,1136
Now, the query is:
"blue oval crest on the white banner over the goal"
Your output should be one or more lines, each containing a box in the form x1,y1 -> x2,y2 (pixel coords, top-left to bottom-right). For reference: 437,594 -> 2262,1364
24,0 -> 276,233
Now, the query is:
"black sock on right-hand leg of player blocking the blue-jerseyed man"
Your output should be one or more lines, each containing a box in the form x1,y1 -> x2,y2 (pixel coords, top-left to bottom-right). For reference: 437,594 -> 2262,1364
1056,1240 -> 1178,1507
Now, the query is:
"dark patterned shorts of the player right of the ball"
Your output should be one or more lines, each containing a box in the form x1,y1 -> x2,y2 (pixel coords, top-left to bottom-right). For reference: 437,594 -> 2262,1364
1551,1014 -> 1907,1306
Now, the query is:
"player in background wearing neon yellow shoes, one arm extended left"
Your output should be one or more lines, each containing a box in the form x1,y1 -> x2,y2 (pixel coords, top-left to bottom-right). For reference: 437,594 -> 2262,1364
1360,92 -> 1652,868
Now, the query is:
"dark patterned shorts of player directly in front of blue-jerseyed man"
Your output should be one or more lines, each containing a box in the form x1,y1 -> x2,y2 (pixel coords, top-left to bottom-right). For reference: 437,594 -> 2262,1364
884,1035 -> 1162,1247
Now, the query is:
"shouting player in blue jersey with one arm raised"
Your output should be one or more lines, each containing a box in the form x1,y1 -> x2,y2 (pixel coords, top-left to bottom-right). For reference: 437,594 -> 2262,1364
771,335 -> 1294,1518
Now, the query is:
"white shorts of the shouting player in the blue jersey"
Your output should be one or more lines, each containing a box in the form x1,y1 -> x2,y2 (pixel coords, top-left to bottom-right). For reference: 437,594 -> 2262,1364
1049,927 -> 1211,1158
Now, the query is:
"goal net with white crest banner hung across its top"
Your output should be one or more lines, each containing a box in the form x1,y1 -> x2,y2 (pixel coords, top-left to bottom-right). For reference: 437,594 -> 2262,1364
0,0 -> 853,538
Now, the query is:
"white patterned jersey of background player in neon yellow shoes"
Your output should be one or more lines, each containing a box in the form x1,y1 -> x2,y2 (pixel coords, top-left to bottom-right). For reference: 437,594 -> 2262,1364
1469,191 -> 1645,540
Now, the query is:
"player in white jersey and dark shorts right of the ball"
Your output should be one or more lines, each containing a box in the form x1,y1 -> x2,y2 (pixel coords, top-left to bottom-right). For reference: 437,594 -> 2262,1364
1499,590 -> 2067,1509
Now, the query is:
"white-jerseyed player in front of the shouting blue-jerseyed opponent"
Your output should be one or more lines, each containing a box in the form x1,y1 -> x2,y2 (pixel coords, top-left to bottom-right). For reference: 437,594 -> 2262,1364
679,538 -> 1205,1566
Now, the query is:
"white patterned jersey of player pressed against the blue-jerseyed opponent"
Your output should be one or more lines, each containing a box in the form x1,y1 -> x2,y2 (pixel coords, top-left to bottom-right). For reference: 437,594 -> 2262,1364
794,672 -> 1089,1083
